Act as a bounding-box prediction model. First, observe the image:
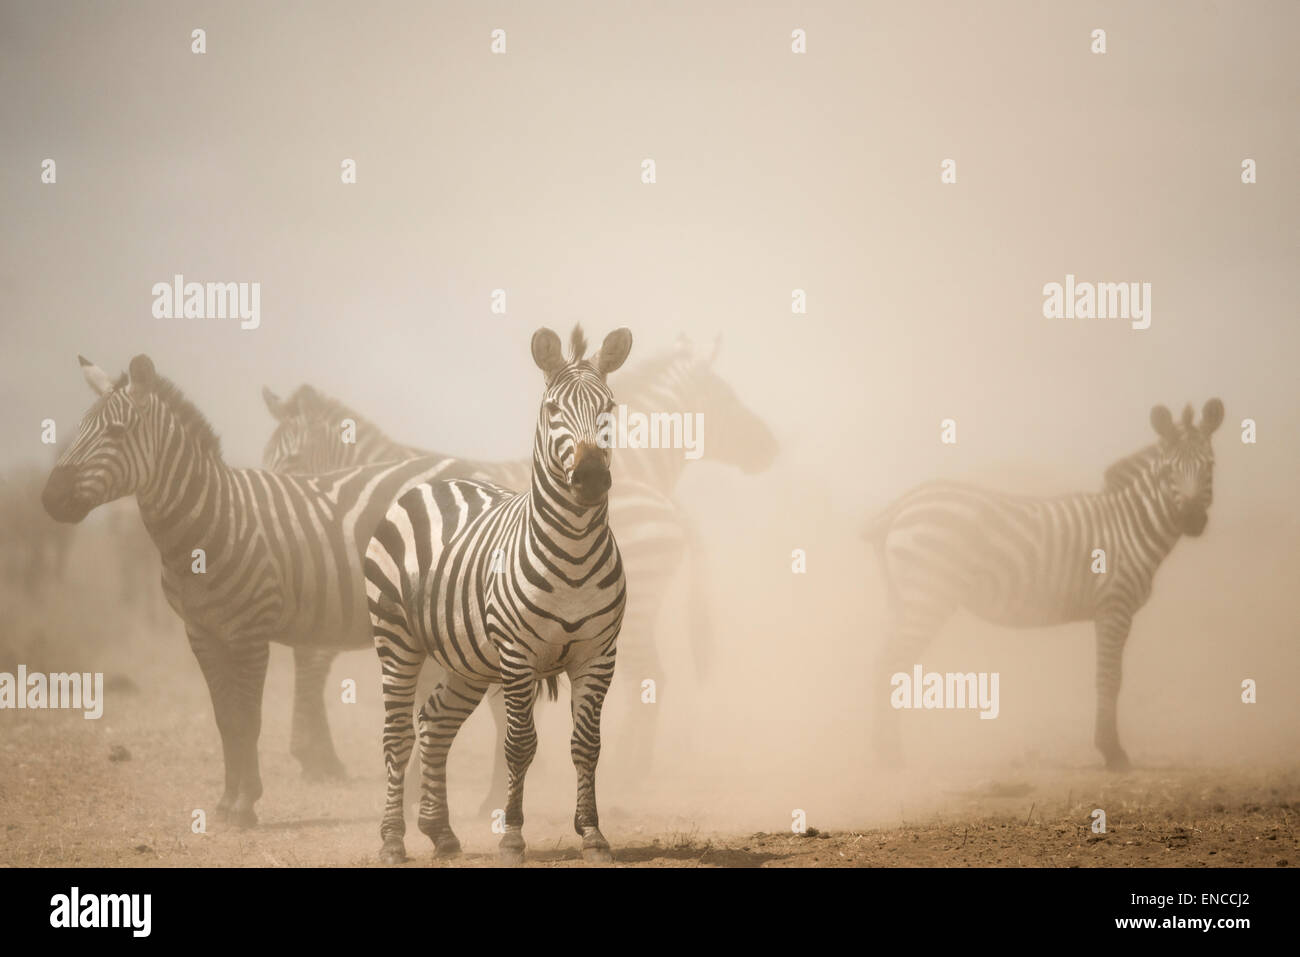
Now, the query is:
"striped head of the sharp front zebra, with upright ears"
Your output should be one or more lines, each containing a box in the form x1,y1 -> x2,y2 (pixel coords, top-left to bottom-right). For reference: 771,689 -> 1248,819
533,326 -> 632,506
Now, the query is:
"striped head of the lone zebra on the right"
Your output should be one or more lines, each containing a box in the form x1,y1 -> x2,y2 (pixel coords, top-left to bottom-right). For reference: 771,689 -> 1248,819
1151,399 -> 1223,537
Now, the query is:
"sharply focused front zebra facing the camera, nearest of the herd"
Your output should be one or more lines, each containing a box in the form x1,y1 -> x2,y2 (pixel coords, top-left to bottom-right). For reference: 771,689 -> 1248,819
365,326 -> 632,865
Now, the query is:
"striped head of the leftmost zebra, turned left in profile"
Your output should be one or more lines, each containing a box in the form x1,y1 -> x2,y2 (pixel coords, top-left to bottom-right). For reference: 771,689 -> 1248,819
40,355 -> 221,521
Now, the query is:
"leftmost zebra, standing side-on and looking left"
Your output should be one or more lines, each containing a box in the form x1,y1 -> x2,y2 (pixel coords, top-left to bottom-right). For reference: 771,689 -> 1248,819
42,355 -> 462,827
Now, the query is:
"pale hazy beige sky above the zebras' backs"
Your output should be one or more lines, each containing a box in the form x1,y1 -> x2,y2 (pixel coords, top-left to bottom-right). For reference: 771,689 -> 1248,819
0,0 -> 1300,511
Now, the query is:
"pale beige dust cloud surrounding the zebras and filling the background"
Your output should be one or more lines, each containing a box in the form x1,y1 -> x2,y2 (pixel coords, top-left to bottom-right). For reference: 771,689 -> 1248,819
0,3 -> 1300,836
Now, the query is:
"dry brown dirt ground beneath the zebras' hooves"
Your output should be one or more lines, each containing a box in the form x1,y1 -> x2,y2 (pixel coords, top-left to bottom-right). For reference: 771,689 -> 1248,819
0,715 -> 1300,867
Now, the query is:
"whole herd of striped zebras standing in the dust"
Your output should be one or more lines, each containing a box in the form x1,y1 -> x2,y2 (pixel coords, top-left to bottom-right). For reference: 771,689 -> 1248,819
42,328 -> 1223,863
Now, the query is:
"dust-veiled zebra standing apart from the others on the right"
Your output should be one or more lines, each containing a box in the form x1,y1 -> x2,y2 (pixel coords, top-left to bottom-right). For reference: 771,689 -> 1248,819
863,399 -> 1223,770
